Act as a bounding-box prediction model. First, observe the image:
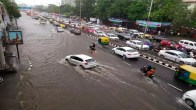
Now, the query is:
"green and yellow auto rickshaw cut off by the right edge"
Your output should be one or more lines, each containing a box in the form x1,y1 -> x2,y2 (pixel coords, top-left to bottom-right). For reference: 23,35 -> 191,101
175,64 -> 196,85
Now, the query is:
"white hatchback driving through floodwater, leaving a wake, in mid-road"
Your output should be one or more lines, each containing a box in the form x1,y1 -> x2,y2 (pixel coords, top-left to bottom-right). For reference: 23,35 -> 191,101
65,54 -> 97,68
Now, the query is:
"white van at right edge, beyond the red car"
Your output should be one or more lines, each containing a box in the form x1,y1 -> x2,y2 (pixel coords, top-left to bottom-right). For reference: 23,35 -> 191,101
179,40 -> 196,50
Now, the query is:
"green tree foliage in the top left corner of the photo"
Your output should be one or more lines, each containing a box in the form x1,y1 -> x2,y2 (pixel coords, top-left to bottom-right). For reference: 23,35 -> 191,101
0,0 -> 21,18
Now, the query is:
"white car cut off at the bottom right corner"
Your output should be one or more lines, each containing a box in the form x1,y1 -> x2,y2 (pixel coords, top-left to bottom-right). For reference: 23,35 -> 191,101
182,90 -> 196,108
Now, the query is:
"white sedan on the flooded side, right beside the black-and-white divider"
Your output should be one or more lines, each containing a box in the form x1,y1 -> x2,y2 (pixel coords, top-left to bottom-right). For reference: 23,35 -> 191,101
112,47 -> 140,59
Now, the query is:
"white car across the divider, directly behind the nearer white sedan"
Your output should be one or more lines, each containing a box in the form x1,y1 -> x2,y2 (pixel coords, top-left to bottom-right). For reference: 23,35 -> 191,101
126,40 -> 149,50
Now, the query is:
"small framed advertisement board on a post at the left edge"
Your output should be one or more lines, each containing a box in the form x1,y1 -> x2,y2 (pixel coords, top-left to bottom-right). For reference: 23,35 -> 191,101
8,31 -> 23,45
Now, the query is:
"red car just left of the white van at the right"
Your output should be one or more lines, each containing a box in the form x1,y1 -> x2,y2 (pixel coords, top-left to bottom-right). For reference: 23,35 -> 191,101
160,39 -> 183,49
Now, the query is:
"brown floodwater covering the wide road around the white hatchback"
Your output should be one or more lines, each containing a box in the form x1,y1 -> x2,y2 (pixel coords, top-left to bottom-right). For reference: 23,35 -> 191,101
14,14 -> 193,110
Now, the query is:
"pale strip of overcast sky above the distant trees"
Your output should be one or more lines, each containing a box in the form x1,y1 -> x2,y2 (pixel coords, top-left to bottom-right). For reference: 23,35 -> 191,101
15,0 -> 61,5
